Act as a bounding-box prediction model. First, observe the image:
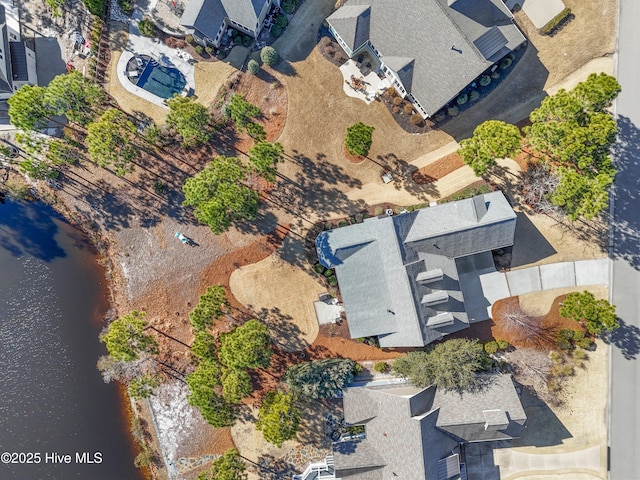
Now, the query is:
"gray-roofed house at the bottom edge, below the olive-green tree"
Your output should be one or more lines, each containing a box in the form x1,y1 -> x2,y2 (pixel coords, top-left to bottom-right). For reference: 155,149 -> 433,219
294,374 -> 527,480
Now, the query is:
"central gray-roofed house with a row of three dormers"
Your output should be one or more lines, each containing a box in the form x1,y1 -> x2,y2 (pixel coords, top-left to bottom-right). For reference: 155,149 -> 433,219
316,191 -> 516,348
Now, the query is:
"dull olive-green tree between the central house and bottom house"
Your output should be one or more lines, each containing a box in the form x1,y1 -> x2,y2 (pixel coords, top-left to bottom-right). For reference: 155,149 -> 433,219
392,338 -> 483,391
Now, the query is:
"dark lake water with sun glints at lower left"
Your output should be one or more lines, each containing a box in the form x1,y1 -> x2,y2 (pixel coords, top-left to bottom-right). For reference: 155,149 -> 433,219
0,202 -> 143,480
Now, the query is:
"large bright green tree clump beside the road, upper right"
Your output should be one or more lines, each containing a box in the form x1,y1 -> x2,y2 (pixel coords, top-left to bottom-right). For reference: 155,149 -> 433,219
525,74 -> 620,220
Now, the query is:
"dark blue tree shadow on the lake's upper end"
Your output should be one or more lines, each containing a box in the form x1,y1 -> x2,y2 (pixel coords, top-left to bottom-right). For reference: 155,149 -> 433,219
0,201 -> 67,262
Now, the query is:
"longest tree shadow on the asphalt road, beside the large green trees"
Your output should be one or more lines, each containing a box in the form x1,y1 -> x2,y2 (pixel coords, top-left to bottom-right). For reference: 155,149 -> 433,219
611,116 -> 640,270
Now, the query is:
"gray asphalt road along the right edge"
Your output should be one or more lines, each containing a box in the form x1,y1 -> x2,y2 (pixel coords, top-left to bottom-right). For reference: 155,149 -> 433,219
609,0 -> 640,480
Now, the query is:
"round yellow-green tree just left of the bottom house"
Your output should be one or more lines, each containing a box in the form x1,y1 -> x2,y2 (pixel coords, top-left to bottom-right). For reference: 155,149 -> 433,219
256,391 -> 300,447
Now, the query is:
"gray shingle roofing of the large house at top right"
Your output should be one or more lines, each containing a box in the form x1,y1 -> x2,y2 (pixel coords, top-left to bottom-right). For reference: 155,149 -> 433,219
327,0 -> 525,115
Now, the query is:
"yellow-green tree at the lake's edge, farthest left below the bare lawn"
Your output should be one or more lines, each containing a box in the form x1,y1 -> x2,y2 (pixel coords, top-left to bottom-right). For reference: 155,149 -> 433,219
100,310 -> 158,362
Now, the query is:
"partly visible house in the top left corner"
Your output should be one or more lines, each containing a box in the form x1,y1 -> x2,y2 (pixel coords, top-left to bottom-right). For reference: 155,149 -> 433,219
0,2 -> 38,100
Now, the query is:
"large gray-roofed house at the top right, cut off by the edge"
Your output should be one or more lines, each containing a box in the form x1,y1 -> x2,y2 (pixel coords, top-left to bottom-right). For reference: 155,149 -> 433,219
327,0 -> 525,118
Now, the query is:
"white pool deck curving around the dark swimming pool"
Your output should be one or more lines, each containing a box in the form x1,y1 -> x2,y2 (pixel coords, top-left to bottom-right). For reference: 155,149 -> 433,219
116,1 -> 196,108
